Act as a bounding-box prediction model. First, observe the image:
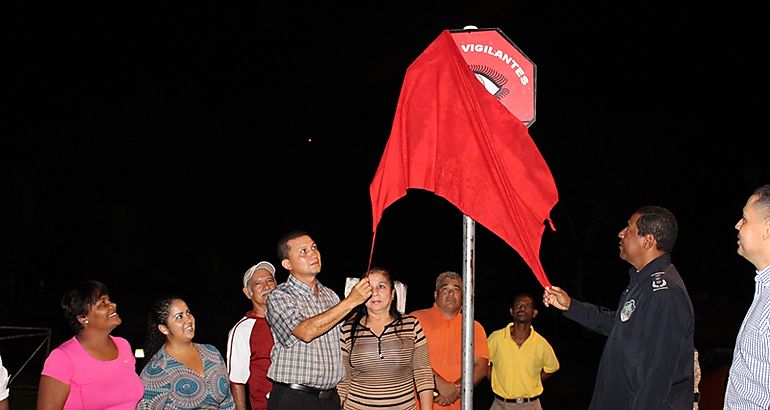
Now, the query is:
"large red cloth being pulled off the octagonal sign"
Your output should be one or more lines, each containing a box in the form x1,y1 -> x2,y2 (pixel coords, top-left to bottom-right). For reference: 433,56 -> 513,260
369,31 -> 558,287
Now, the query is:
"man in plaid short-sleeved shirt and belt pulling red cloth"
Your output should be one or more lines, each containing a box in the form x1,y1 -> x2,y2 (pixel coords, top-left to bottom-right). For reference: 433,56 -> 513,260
267,231 -> 372,410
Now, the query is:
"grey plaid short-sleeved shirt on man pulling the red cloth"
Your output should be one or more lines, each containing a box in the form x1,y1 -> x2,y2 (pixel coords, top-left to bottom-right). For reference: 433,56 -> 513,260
266,275 -> 345,389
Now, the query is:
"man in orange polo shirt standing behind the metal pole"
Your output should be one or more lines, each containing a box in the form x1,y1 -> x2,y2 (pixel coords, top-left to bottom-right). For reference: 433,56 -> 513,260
412,271 -> 489,410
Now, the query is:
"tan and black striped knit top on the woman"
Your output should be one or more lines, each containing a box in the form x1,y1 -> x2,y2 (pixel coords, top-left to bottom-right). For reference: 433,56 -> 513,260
337,315 -> 434,409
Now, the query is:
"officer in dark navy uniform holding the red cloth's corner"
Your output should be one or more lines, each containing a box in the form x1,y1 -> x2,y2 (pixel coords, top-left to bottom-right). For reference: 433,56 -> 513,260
543,206 -> 695,410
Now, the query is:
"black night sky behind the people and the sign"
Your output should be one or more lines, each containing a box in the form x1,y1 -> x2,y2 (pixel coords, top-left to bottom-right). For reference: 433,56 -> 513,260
0,1 -> 770,406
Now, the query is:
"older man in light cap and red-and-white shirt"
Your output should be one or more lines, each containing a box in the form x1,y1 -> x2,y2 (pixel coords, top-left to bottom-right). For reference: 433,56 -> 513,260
227,261 -> 276,410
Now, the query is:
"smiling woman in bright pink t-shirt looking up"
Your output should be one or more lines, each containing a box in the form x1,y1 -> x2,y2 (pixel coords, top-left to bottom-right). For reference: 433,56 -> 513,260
37,281 -> 144,410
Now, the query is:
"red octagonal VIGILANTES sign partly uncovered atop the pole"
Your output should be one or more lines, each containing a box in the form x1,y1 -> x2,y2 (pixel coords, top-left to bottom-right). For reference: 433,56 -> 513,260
450,28 -> 536,127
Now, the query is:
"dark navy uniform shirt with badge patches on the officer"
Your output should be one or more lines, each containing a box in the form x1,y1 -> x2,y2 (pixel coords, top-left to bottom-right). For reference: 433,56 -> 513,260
564,254 -> 695,410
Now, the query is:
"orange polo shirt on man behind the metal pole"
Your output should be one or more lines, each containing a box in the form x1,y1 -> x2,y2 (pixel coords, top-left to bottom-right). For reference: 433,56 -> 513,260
411,303 -> 489,410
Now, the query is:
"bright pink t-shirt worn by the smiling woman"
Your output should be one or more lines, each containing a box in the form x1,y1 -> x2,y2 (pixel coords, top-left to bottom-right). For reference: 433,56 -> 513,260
42,336 -> 144,410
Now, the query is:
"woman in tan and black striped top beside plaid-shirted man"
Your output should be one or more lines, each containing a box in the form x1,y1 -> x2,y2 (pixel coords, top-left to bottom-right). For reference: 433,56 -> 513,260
337,268 -> 434,410
